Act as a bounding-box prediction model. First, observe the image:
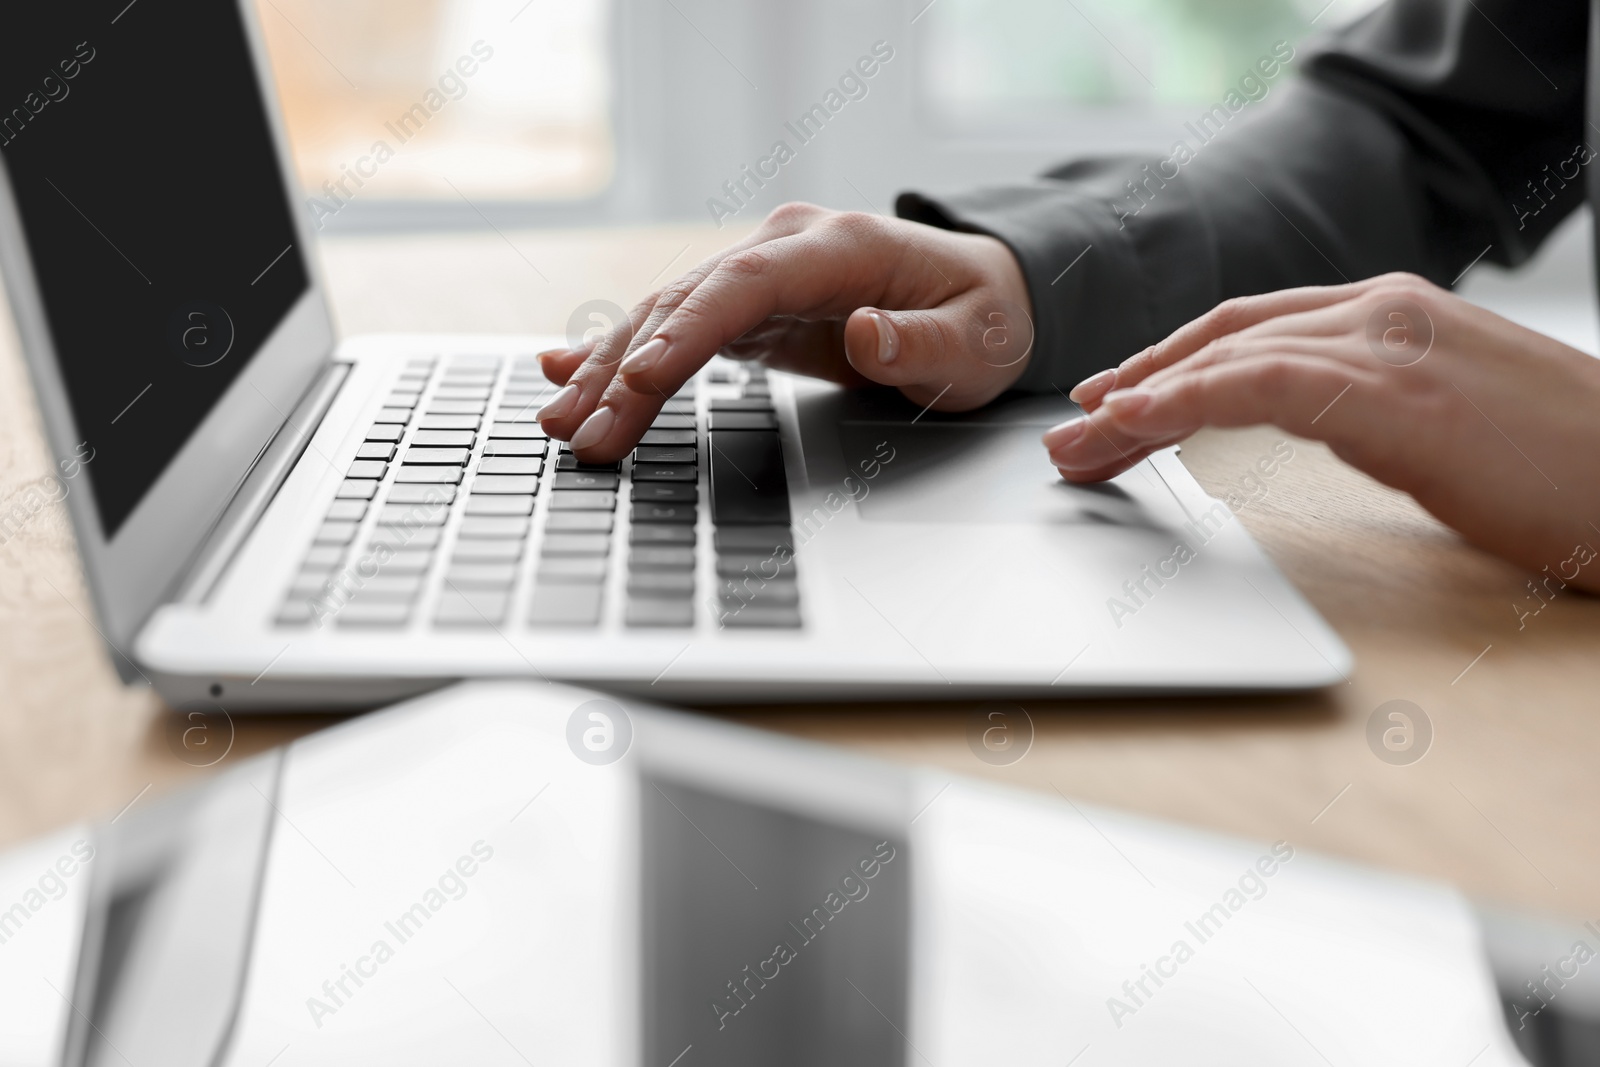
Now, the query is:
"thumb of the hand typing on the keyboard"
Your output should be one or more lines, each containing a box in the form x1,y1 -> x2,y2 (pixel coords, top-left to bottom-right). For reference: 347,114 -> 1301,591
845,294 -> 1034,408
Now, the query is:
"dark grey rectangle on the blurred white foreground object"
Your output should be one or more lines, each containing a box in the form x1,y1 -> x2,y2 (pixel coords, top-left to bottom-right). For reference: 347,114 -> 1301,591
642,777 -> 910,1067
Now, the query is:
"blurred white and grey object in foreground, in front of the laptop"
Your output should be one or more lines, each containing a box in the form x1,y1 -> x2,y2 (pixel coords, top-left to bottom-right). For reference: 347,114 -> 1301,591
0,681 -> 1548,1067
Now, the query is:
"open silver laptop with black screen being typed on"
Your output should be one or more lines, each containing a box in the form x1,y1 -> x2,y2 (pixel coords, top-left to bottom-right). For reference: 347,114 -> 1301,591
0,0 -> 1350,709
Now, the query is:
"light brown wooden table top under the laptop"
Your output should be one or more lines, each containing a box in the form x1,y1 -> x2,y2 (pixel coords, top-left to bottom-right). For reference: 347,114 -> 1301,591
0,227 -> 1600,918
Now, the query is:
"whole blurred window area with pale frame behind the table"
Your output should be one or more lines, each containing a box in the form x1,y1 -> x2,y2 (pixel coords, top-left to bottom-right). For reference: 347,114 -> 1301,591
246,0 -> 1376,230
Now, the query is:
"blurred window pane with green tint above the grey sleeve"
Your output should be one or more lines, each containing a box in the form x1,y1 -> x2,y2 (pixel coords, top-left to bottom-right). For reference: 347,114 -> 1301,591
917,0 -> 1382,123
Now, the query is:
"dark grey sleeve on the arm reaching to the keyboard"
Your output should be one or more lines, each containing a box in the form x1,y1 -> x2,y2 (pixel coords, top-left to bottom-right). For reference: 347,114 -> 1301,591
898,0 -> 1600,390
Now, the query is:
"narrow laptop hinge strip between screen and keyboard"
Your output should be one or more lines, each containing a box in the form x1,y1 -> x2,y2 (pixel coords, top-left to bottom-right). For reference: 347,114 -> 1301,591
176,363 -> 350,603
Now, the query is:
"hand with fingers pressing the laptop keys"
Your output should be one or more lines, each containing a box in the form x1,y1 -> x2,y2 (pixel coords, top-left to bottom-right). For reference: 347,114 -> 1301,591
539,203 -> 1034,462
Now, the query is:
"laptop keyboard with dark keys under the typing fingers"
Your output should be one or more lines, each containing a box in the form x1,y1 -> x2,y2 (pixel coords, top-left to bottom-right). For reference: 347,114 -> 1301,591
277,355 -> 800,630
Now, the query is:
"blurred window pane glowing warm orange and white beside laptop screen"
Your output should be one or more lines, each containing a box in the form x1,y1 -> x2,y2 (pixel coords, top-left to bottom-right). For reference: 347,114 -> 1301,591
256,0 -> 616,204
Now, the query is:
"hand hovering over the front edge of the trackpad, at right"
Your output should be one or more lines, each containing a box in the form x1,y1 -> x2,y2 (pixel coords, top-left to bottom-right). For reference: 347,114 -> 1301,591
1045,275 -> 1600,592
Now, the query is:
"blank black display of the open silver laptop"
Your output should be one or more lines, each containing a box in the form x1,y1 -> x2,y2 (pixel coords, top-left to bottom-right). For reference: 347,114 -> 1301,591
0,0 -> 309,539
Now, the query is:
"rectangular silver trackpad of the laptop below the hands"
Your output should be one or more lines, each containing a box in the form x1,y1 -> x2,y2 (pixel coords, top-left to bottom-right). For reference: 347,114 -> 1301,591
837,421 -> 1149,525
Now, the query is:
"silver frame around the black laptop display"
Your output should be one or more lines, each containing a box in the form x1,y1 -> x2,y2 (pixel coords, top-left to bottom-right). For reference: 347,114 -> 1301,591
0,0 -> 336,668
